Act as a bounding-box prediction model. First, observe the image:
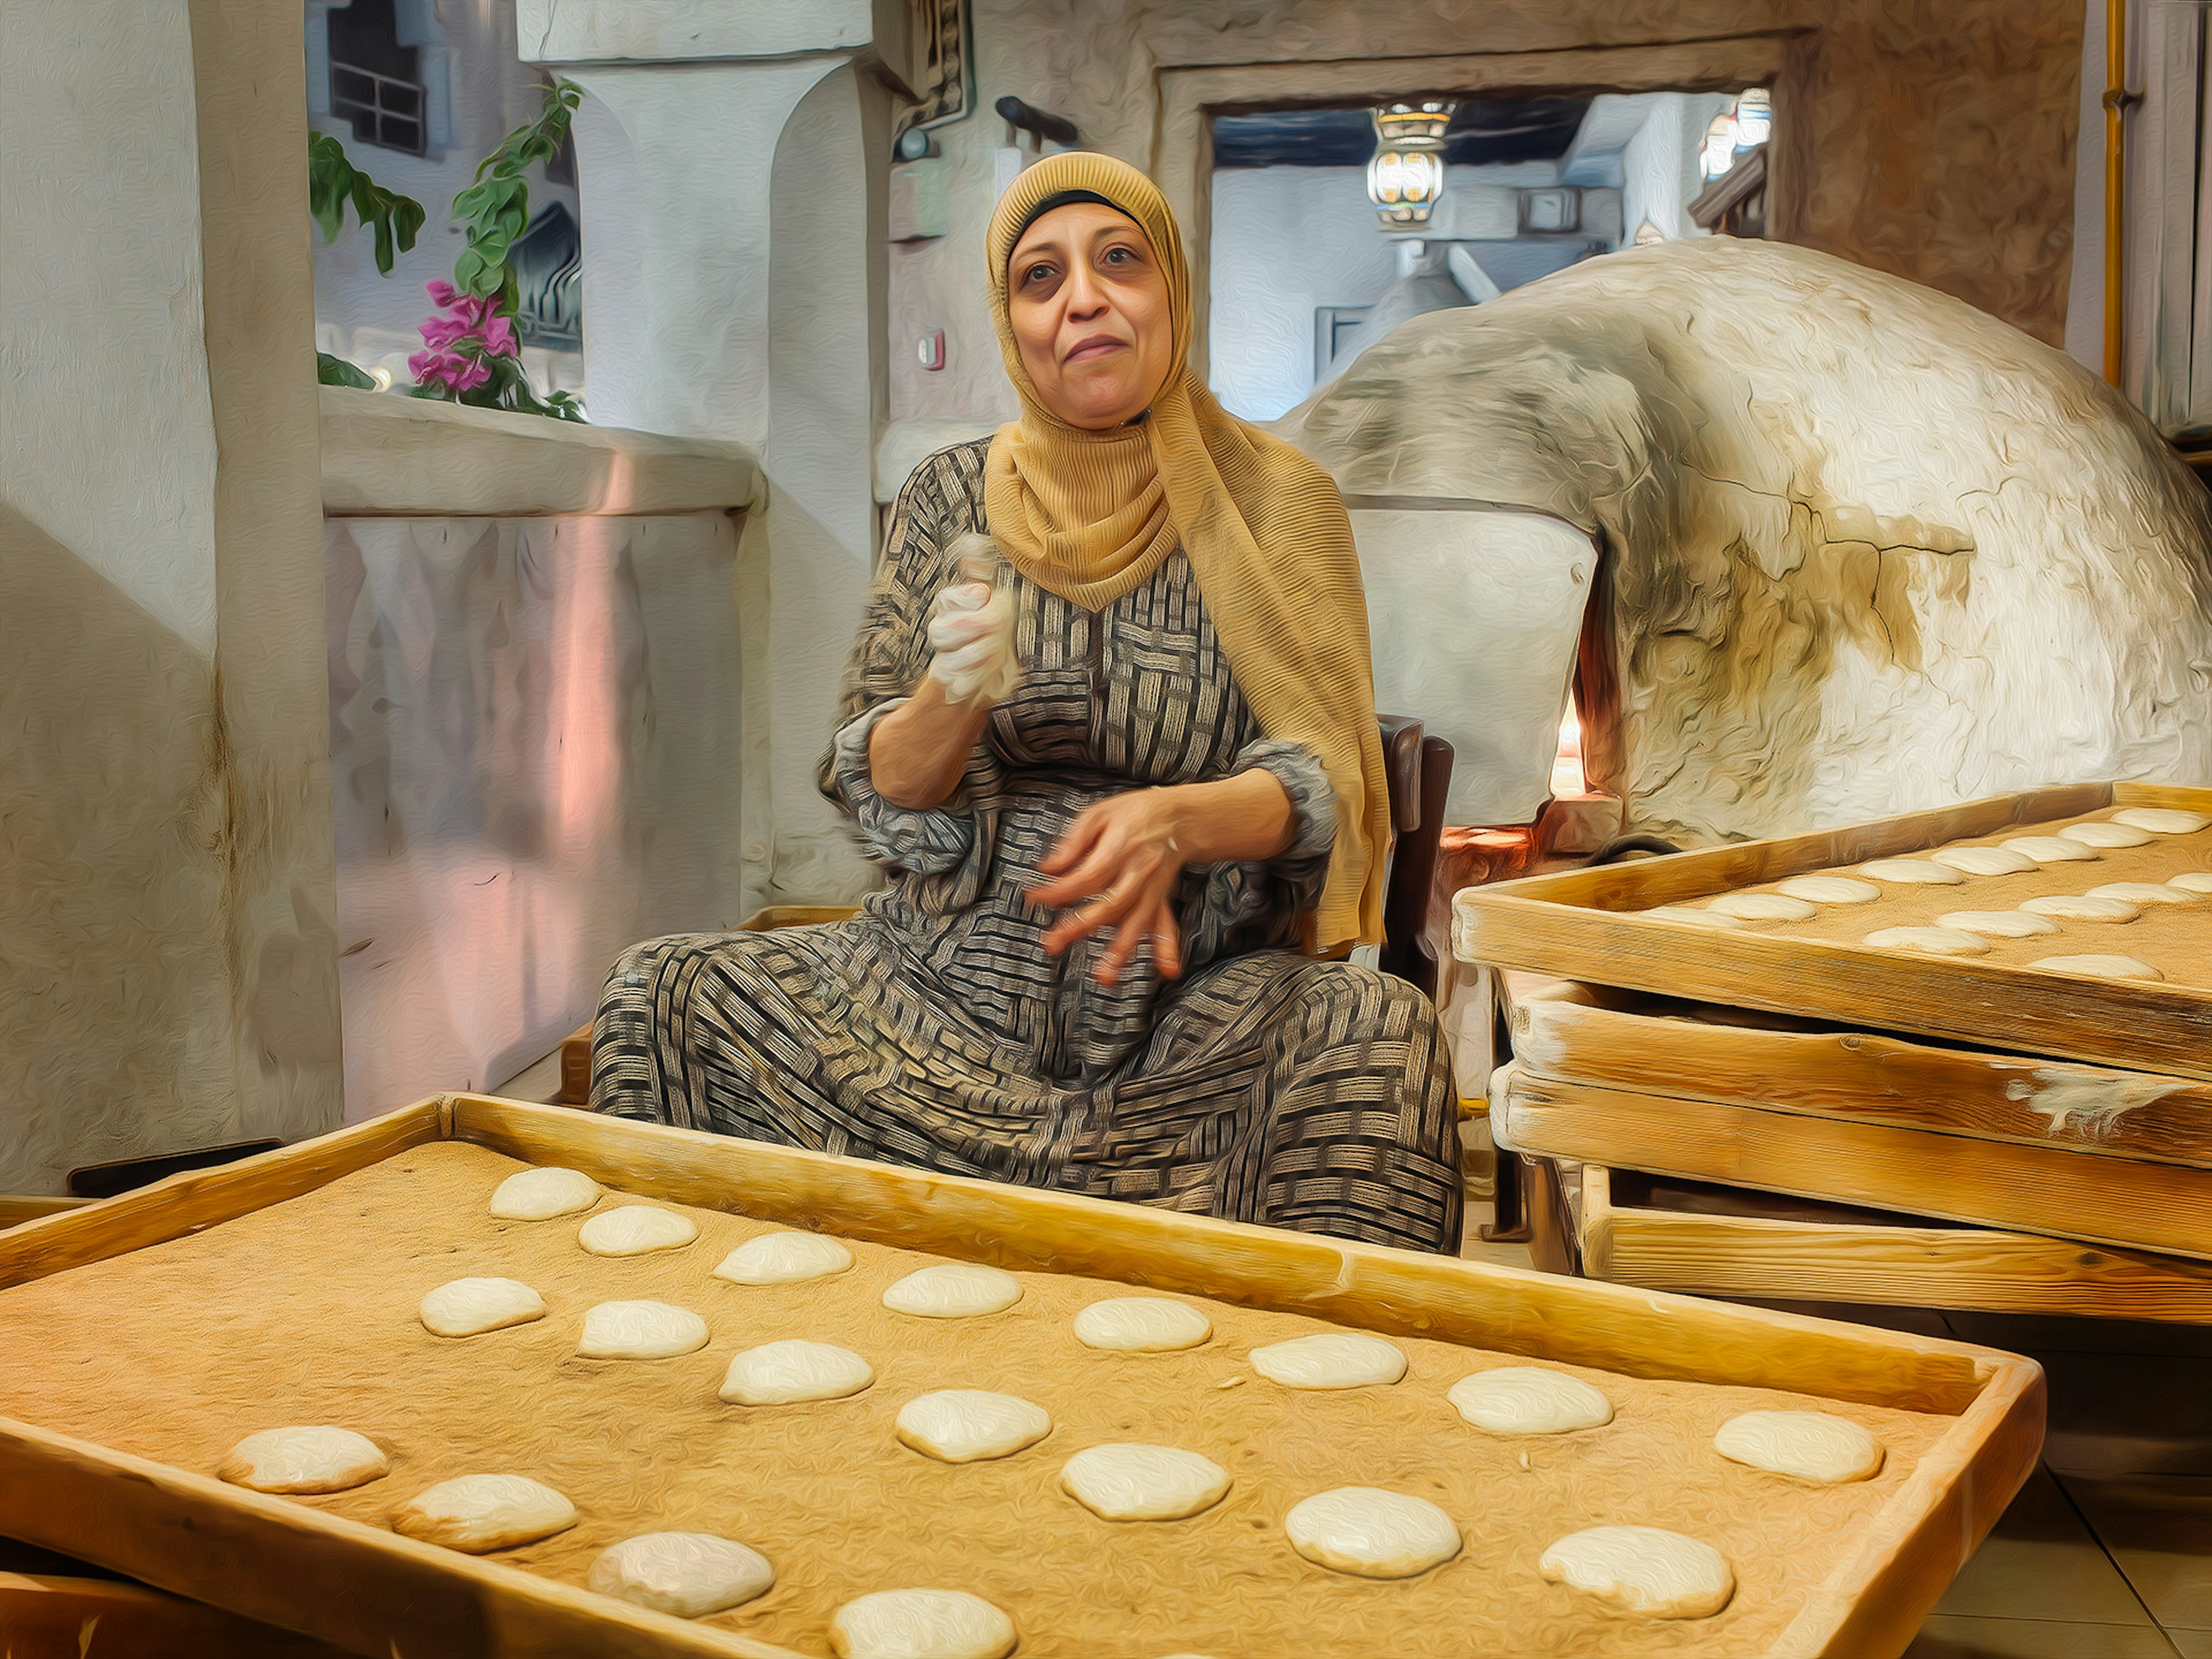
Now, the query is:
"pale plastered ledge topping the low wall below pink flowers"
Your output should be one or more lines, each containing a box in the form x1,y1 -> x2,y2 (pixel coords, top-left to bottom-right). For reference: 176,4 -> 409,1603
323,387 -> 761,518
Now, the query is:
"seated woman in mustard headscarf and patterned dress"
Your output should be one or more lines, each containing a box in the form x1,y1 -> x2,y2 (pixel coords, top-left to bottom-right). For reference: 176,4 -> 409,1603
590,153 -> 1460,1250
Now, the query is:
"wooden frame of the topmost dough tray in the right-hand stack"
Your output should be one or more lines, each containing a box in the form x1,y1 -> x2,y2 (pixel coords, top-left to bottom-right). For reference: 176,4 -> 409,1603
1453,783 -> 2212,1080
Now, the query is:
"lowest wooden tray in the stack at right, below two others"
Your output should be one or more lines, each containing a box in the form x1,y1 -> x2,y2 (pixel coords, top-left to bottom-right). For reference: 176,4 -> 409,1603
1577,1164 -> 2212,1325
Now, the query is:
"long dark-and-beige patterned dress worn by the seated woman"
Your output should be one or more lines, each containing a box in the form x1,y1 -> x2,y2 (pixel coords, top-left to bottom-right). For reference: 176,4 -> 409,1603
590,442 -> 1460,1250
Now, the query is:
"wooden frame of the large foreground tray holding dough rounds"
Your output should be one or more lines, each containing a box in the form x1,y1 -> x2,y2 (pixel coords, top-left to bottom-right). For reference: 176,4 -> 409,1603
0,1095 -> 2044,1659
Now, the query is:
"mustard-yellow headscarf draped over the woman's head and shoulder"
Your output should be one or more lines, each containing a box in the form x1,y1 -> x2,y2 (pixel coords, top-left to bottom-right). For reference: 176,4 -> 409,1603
984,150 -> 1389,951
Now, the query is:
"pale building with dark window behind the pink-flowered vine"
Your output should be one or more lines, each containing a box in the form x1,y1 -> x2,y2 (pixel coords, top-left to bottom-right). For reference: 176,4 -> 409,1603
305,0 -> 584,392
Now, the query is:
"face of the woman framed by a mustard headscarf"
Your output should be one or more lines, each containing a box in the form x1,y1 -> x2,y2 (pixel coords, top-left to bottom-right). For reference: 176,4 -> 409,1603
1006,201 -> 1175,431
